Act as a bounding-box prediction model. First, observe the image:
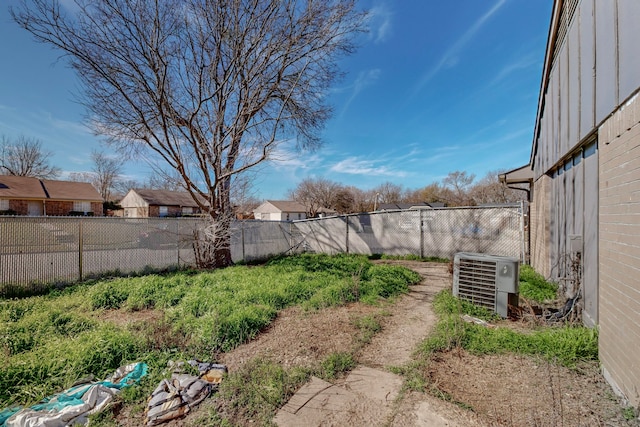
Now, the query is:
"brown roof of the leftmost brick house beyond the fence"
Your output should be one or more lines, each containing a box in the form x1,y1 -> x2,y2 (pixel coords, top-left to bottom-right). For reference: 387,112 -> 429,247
0,175 -> 102,202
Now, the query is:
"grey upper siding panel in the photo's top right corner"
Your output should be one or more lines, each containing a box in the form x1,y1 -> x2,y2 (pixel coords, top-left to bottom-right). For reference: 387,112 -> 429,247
618,0 -> 640,101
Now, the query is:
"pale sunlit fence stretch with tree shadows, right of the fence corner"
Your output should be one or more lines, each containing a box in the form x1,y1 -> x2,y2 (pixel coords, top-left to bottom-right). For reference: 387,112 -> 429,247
294,204 -> 526,261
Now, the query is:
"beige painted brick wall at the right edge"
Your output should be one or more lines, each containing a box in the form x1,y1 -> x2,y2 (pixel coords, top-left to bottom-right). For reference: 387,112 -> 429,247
598,96 -> 640,407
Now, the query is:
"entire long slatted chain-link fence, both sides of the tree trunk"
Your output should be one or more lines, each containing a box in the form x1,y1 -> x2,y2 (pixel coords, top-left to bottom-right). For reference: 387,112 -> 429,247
0,205 -> 525,297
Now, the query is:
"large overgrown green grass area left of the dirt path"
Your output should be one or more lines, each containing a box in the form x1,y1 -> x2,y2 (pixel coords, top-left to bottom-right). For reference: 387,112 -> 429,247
0,255 -> 419,407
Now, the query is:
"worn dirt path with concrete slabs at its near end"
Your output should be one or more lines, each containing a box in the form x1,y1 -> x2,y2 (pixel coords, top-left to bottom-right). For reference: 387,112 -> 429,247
274,261 -> 477,427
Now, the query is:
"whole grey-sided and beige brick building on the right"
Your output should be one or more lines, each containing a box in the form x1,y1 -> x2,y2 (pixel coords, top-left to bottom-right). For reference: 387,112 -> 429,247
510,0 -> 640,407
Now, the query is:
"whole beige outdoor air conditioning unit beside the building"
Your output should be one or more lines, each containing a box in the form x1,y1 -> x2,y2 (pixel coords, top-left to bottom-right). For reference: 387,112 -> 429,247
453,252 -> 520,317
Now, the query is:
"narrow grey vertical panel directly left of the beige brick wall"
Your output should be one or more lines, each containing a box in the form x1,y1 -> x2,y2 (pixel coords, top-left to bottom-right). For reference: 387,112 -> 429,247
582,143 -> 598,325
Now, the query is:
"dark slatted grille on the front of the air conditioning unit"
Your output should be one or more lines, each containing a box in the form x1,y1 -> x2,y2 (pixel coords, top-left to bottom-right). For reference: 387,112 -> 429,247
458,258 -> 497,311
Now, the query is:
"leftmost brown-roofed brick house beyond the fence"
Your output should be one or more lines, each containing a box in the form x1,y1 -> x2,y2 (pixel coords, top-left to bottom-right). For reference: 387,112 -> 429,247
0,175 -> 103,216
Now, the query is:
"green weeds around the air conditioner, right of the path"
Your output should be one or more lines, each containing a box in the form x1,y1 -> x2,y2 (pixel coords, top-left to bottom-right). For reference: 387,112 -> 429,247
395,266 -> 598,403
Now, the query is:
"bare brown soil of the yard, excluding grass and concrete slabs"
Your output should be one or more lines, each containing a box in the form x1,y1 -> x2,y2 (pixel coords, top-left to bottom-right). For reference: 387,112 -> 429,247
120,261 -> 640,427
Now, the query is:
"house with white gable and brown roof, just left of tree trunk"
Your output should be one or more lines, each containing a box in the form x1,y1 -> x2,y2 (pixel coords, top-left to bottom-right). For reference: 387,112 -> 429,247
119,188 -> 206,218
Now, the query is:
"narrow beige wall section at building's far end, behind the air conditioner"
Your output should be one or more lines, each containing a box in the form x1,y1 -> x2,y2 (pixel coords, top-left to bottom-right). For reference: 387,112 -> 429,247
529,175 -> 551,277
